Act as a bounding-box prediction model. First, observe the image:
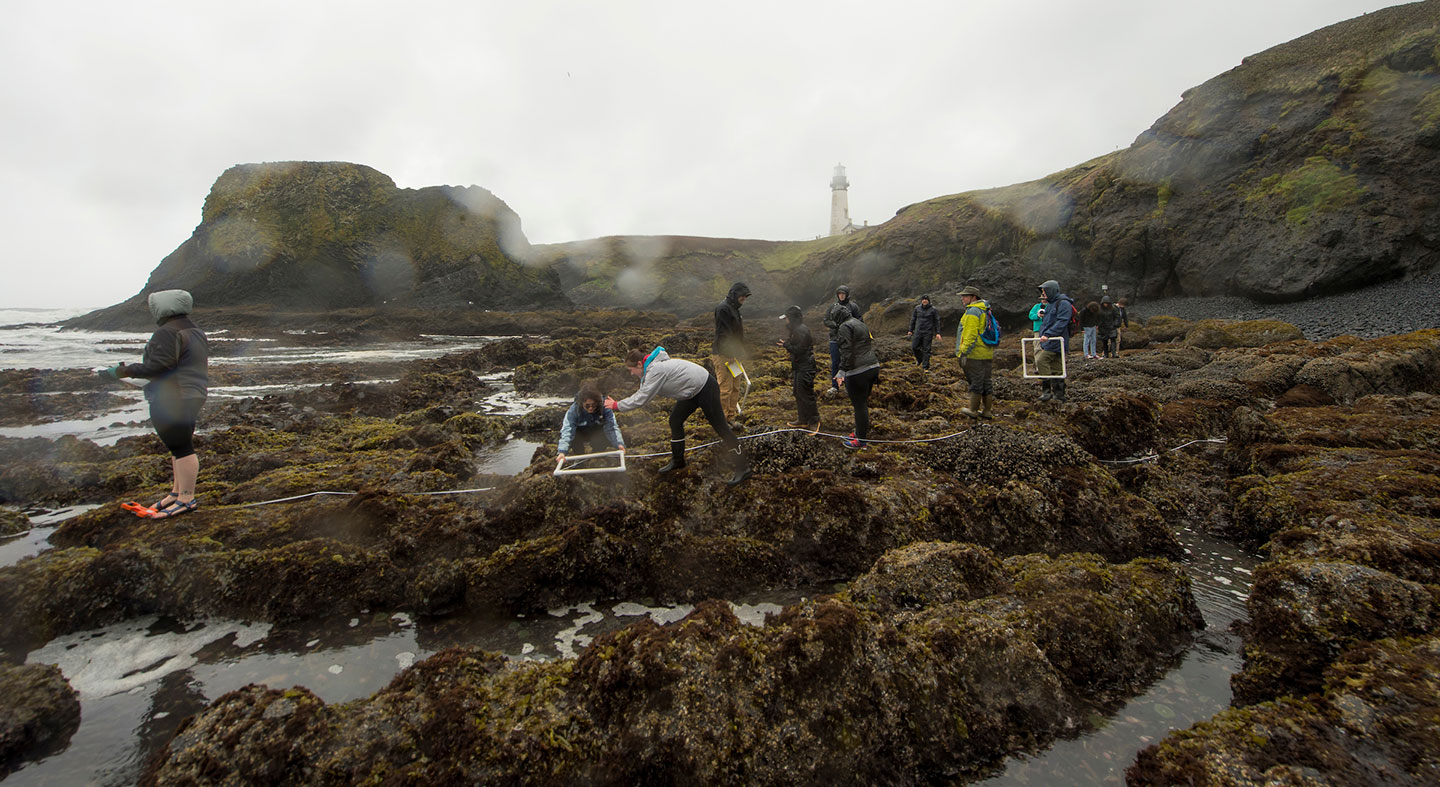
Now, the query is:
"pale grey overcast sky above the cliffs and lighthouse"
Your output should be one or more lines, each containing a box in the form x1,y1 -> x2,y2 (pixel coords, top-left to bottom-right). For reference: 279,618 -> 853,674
0,0 -> 1394,306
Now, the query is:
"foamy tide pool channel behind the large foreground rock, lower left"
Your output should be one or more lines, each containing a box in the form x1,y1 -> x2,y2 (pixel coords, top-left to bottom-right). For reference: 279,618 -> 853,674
6,587 -> 812,786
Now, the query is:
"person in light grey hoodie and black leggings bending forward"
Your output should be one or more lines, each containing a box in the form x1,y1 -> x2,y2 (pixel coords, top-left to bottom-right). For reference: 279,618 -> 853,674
605,347 -> 752,486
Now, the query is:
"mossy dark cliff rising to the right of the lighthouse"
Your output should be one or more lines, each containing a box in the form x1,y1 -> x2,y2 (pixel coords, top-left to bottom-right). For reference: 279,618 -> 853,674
793,1 -> 1440,316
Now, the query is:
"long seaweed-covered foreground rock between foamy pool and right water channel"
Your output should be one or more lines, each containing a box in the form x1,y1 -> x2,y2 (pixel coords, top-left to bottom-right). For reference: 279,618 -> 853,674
148,545 -> 1197,784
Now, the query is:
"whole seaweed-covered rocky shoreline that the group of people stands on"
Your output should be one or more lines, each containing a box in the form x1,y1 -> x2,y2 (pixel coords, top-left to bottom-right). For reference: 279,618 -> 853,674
0,312 -> 1440,783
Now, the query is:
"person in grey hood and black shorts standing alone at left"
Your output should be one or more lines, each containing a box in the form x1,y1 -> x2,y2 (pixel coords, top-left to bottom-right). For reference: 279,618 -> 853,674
99,289 -> 210,519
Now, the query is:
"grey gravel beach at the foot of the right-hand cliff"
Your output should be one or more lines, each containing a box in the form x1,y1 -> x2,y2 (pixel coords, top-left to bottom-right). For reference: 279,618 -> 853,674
1129,270 -> 1440,340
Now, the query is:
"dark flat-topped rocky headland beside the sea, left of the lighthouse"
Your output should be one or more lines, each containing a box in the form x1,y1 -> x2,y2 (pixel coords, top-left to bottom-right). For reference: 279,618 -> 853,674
75,161 -> 569,329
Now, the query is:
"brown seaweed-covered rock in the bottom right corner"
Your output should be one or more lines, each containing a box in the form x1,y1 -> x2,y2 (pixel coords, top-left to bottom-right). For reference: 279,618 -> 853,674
1125,636 -> 1440,787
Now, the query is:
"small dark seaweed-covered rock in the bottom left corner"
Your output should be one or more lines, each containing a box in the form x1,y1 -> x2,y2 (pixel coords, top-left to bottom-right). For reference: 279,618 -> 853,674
0,665 -> 81,778
